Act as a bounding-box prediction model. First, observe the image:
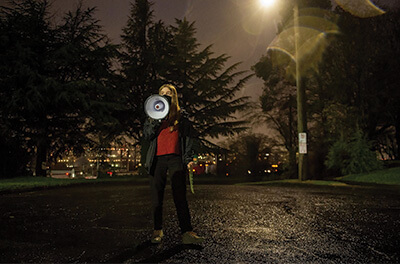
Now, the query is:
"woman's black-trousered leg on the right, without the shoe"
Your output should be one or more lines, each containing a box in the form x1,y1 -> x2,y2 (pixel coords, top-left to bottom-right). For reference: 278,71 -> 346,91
168,156 -> 193,233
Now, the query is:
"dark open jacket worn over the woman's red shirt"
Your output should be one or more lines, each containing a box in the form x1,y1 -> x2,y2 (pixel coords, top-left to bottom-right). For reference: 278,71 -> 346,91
143,111 -> 195,175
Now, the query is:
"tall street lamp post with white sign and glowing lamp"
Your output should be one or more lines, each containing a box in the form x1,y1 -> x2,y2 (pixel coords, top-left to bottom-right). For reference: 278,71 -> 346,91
260,0 -> 308,181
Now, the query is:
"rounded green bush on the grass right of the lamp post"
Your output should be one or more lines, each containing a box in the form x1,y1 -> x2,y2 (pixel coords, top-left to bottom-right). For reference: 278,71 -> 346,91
325,131 -> 382,175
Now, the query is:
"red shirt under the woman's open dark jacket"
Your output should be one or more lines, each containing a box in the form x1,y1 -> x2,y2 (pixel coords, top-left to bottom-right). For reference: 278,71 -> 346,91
156,121 -> 181,156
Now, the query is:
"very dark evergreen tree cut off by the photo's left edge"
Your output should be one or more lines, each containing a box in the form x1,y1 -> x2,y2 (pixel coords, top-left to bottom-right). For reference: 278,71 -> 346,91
0,1 -> 55,177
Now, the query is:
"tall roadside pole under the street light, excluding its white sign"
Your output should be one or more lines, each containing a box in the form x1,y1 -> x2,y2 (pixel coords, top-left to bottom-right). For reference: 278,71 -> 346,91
294,2 -> 307,181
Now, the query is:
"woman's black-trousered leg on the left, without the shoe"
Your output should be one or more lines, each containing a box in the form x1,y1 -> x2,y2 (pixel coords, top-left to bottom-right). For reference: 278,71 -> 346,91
150,157 -> 168,230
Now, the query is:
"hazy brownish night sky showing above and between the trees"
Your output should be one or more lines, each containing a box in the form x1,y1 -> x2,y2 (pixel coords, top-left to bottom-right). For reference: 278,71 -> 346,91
53,0 -> 278,101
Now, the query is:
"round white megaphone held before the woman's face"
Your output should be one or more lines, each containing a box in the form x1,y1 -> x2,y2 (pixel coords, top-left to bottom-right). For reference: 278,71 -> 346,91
144,94 -> 171,119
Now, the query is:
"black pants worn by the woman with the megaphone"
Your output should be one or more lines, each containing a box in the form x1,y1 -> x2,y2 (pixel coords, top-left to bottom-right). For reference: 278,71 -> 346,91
150,155 -> 192,233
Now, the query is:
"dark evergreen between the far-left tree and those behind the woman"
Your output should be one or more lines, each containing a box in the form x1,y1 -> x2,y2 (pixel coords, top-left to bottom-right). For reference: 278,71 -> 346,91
54,4 -> 122,157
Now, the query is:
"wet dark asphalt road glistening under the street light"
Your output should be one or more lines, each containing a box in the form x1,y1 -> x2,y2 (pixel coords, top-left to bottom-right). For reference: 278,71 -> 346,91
0,183 -> 400,263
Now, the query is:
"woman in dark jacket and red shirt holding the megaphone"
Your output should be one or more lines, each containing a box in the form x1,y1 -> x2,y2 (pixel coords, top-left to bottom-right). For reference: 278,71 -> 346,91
143,84 -> 204,244
